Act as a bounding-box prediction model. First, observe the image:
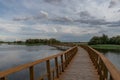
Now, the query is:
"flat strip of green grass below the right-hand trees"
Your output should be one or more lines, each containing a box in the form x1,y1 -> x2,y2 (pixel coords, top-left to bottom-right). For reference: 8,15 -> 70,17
90,44 -> 120,50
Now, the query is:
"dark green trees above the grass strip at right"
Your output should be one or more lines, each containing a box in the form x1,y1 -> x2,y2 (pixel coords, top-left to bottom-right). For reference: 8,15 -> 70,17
88,34 -> 120,45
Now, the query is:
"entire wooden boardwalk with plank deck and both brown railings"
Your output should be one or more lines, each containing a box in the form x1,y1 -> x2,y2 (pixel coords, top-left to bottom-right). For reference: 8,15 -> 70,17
0,46 -> 120,80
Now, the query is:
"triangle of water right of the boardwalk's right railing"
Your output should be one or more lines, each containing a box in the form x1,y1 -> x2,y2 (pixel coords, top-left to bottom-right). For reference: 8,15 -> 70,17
97,49 -> 120,70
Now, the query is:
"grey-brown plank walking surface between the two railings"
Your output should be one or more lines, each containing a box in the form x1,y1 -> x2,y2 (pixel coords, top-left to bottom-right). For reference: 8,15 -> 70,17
58,47 -> 99,80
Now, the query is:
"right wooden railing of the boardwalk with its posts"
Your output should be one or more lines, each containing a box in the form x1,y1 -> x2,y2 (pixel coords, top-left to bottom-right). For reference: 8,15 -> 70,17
81,45 -> 120,80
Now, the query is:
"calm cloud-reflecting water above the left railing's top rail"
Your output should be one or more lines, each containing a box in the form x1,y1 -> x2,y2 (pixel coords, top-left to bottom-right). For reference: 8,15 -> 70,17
0,44 -> 61,71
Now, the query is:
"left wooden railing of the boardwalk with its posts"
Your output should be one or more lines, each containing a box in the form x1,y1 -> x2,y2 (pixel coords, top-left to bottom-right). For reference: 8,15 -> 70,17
0,46 -> 78,80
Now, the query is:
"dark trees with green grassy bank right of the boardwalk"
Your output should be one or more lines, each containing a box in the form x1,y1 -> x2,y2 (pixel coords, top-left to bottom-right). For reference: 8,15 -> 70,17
88,34 -> 120,50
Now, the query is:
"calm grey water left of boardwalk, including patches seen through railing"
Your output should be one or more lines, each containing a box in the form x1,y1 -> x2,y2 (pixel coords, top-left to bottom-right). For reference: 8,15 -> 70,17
0,44 -> 61,80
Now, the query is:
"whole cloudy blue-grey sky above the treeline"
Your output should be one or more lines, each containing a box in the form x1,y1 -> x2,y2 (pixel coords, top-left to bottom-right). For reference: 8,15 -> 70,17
0,0 -> 120,42
